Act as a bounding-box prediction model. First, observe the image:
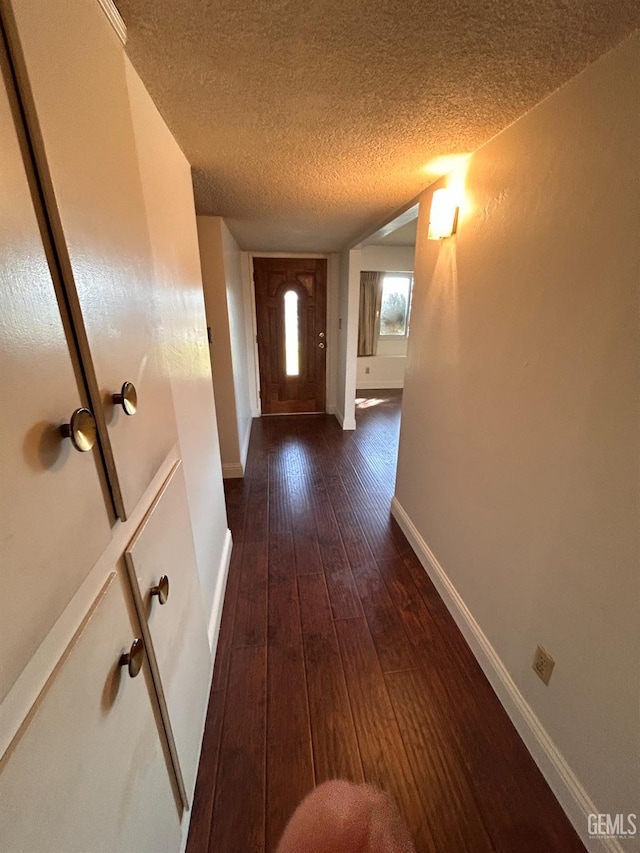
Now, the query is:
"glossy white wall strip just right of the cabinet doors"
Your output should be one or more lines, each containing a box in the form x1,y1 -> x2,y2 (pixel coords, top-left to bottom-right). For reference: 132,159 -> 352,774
126,60 -> 230,621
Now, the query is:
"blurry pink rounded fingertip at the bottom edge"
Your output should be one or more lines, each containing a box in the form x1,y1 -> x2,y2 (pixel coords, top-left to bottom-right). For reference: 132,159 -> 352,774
276,779 -> 415,853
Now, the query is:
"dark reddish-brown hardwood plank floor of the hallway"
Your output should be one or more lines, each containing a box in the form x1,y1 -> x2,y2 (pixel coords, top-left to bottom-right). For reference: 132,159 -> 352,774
187,391 -> 584,853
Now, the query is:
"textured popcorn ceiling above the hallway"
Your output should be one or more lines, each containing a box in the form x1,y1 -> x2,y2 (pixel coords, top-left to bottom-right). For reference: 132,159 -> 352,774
116,0 -> 640,252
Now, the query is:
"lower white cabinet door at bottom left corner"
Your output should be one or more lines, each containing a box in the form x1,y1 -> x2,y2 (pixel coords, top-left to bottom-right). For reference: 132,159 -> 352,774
0,574 -> 181,853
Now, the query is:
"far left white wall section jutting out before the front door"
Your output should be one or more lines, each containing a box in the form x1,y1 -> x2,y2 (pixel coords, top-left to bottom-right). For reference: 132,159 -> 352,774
197,216 -> 251,477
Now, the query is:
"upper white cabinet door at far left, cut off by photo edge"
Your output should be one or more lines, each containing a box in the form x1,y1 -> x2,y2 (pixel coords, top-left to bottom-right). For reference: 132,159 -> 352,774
0,33 -> 111,702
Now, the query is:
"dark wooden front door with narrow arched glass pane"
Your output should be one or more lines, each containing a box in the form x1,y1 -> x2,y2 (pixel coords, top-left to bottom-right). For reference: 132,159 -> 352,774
253,258 -> 327,415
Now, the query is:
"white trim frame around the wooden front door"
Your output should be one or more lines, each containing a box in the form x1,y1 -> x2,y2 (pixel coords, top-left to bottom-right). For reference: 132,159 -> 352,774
242,251 -> 338,418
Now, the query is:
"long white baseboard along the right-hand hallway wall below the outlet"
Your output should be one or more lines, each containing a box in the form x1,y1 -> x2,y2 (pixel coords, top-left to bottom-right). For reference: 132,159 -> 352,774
391,497 -> 623,853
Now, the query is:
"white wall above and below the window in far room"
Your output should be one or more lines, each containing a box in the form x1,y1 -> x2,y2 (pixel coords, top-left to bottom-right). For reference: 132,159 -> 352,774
356,245 -> 415,389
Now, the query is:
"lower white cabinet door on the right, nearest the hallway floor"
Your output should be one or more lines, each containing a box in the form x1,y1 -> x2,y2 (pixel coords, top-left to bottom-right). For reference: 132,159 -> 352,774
125,463 -> 213,805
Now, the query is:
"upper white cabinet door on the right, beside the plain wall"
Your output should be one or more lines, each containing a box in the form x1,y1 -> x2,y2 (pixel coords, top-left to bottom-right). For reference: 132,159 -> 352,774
7,0 -> 176,517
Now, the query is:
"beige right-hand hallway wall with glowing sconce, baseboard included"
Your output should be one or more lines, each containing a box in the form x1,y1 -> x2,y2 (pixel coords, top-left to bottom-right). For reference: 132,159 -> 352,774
394,34 -> 640,850
